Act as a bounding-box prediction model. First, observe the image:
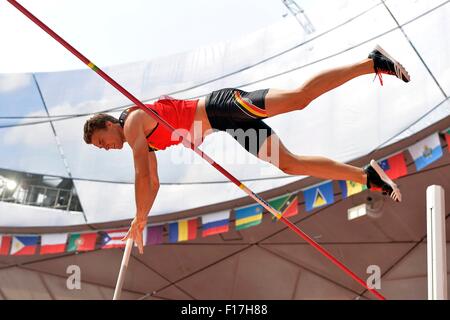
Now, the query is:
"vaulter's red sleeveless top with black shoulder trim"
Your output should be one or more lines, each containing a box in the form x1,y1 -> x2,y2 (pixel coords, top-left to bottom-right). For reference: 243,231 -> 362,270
119,97 -> 198,151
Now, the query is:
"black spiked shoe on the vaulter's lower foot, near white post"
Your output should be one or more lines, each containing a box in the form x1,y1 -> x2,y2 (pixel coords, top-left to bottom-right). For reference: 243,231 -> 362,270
364,160 -> 402,202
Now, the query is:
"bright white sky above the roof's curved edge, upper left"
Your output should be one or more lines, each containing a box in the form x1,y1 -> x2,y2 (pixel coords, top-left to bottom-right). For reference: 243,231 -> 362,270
0,0 -> 296,73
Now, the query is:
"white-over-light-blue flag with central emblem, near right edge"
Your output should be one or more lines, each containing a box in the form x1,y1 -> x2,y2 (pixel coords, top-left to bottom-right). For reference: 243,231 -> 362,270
408,133 -> 442,171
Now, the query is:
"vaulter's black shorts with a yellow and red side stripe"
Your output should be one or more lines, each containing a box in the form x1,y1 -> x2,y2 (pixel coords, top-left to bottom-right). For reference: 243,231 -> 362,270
206,88 -> 274,156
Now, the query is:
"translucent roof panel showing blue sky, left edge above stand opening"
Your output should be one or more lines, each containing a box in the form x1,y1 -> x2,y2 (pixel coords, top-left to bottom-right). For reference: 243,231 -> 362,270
0,74 -> 67,176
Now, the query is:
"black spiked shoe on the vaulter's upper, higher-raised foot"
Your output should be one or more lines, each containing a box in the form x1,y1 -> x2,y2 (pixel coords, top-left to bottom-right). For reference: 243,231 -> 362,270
369,45 -> 411,85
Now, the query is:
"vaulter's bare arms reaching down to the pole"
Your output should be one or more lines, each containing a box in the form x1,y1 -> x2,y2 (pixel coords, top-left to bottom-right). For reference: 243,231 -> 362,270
124,117 -> 159,253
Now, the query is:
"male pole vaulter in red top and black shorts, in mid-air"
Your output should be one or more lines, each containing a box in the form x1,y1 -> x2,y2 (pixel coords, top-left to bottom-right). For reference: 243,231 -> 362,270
84,46 -> 410,253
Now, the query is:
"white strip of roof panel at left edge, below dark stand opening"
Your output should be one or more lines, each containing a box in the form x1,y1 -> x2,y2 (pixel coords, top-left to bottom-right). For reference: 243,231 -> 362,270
0,202 -> 85,227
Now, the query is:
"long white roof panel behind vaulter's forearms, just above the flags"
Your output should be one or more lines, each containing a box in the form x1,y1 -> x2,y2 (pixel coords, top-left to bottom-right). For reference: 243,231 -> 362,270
75,177 -> 299,223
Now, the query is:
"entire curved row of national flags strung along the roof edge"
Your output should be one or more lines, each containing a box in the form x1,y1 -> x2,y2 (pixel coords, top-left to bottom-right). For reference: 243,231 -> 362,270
0,129 -> 450,255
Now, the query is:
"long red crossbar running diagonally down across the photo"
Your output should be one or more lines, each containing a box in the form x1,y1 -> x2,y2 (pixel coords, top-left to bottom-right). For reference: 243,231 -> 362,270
7,0 -> 386,300
